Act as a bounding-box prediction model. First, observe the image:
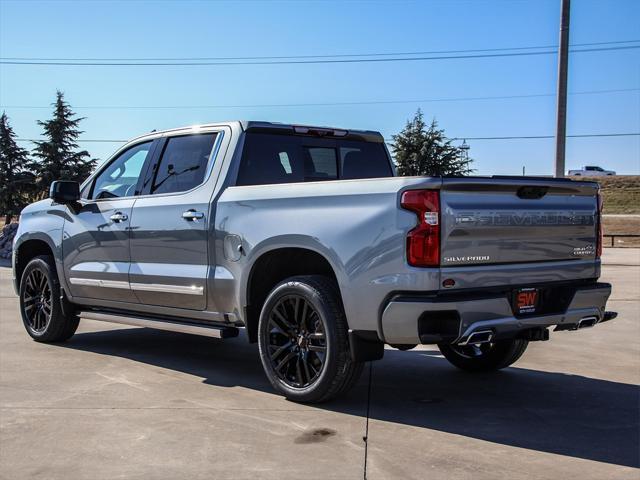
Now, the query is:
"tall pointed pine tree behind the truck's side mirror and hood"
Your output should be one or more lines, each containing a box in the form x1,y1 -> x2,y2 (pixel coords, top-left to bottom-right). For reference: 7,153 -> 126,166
33,90 -> 96,195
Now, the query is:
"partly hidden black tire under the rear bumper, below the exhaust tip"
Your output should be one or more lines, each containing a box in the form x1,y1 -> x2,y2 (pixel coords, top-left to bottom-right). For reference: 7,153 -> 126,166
438,338 -> 529,372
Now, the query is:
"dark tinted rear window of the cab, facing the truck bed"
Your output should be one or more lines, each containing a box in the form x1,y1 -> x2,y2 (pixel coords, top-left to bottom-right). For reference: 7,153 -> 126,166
236,132 -> 393,185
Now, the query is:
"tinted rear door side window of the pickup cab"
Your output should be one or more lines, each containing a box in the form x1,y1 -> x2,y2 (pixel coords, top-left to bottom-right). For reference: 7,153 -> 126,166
149,133 -> 216,195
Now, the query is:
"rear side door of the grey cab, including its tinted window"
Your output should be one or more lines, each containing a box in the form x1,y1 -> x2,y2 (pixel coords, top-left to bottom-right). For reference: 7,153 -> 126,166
129,131 -> 222,310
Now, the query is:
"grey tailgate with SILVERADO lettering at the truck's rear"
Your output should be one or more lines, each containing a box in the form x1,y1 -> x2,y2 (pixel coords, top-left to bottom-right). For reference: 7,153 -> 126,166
440,177 -> 598,267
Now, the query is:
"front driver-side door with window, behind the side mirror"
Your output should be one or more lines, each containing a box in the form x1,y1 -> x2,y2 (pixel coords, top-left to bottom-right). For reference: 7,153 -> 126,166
63,140 -> 156,303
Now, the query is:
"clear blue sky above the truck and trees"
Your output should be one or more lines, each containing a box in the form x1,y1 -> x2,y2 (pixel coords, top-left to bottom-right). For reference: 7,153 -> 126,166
0,0 -> 640,174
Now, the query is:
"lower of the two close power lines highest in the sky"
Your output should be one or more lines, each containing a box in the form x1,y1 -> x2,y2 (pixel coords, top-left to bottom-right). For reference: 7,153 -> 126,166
0,45 -> 640,67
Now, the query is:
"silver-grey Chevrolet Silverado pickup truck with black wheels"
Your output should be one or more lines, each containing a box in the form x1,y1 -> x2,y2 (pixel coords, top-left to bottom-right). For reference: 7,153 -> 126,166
13,122 -> 615,402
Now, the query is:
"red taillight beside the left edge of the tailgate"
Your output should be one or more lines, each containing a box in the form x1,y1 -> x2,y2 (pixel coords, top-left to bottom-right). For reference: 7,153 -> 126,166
400,190 -> 440,267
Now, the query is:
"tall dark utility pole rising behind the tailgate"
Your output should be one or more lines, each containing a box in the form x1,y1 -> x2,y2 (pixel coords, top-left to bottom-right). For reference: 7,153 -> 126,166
555,0 -> 571,177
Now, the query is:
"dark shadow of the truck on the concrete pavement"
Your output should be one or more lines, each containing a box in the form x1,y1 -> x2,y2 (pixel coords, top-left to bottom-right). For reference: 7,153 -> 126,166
62,329 -> 640,467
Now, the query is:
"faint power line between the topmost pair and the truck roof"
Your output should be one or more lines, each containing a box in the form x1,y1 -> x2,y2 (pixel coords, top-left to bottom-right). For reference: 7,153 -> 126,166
0,88 -> 640,110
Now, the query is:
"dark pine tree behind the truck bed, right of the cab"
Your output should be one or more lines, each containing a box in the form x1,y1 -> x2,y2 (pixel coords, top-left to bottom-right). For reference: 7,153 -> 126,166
391,110 -> 473,177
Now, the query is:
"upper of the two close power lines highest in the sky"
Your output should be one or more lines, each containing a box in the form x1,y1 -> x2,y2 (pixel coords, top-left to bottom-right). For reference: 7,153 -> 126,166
0,39 -> 640,62
